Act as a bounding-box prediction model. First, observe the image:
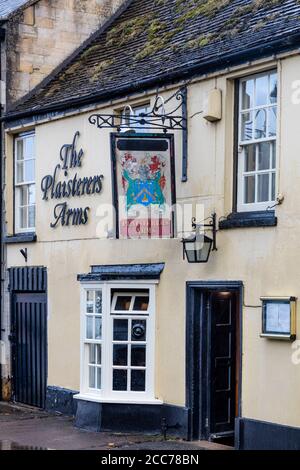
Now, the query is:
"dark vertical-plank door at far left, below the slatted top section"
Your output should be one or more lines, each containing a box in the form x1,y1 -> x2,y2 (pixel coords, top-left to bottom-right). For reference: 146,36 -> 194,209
11,292 -> 47,408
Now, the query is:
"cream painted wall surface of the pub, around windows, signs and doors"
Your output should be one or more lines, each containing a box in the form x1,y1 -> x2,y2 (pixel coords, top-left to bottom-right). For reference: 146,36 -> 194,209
8,57 -> 300,426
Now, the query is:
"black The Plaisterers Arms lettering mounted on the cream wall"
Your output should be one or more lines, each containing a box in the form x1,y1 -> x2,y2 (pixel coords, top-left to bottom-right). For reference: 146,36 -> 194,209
41,131 -> 103,228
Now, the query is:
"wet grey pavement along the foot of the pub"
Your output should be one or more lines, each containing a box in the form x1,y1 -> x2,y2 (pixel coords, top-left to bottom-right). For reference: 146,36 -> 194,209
0,402 -> 231,451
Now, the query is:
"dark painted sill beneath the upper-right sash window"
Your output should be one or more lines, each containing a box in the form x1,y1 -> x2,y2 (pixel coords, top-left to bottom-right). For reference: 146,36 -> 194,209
219,211 -> 277,230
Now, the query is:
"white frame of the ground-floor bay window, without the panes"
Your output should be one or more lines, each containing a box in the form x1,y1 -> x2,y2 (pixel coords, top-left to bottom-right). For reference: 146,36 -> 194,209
75,281 -> 162,404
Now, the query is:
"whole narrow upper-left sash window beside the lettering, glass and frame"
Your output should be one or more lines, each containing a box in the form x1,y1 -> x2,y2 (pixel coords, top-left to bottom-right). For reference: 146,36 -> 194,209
14,133 -> 35,232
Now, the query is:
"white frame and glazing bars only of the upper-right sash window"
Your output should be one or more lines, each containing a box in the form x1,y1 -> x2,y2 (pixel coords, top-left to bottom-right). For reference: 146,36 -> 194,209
237,69 -> 280,212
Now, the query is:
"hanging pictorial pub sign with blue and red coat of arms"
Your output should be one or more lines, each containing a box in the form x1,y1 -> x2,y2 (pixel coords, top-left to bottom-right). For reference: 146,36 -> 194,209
112,134 -> 175,238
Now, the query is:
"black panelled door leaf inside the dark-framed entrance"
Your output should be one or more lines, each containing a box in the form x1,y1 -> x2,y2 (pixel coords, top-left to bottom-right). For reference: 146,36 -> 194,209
208,292 -> 236,436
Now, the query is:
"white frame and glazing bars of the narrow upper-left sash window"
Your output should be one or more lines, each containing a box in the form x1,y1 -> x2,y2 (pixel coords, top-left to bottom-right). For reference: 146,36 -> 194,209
14,131 -> 36,233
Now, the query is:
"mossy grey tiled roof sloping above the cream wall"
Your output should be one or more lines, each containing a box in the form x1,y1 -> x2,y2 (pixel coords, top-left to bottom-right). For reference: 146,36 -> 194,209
6,0 -> 300,120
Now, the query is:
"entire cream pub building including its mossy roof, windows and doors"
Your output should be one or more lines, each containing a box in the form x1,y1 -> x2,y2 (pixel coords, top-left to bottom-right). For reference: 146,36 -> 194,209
2,0 -> 300,449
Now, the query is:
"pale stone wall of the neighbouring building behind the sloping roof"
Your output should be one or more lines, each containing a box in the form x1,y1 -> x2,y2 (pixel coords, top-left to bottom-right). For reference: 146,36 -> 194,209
6,0 -> 124,106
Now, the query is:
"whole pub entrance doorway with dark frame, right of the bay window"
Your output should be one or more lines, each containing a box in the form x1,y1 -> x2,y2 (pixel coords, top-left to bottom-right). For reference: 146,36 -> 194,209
186,281 -> 242,445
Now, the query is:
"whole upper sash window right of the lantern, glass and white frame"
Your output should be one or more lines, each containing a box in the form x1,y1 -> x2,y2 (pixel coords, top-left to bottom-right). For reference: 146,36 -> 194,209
237,71 -> 277,212
